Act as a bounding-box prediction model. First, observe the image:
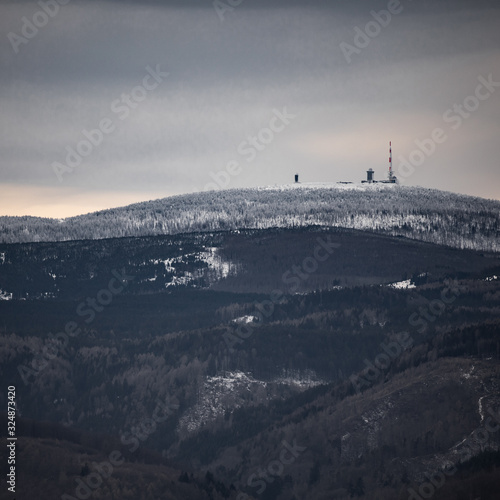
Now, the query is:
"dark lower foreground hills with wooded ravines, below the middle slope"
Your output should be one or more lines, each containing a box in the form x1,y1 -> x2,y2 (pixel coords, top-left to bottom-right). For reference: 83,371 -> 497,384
0,273 -> 500,500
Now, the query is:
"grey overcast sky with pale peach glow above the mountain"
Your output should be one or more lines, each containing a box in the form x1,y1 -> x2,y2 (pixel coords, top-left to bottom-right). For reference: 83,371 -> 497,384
0,0 -> 500,217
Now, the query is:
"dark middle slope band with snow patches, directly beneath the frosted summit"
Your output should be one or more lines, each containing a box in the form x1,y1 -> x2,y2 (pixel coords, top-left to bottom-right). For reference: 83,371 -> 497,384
0,227 -> 500,300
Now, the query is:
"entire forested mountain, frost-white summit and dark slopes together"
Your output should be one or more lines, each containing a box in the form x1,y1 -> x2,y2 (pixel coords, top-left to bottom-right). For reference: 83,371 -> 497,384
0,186 -> 500,500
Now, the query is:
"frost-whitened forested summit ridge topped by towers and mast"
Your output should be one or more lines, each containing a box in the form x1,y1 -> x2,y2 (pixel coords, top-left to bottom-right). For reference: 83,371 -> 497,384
0,183 -> 500,252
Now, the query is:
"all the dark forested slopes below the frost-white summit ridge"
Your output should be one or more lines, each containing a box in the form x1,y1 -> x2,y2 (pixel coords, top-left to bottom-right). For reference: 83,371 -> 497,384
0,228 -> 500,500
